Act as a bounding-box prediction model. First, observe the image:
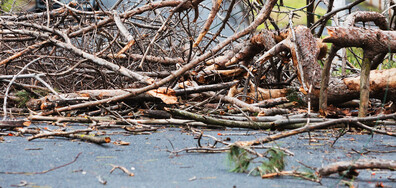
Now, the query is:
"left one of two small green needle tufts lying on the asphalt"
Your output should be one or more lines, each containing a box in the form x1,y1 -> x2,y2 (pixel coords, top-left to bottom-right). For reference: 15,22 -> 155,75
227,146 -> 252,173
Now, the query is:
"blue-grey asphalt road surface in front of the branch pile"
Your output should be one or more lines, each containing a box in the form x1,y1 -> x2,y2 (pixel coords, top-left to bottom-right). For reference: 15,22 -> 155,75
0,124 -> 396,188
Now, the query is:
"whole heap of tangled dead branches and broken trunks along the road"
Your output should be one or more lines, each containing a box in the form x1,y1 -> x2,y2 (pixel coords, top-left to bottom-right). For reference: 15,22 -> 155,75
0,0 -> 396,185
